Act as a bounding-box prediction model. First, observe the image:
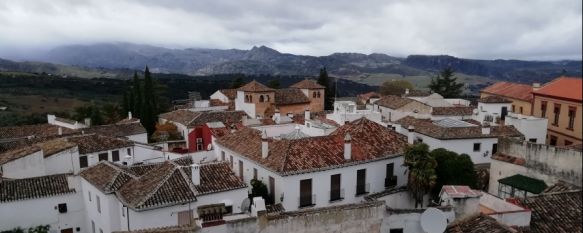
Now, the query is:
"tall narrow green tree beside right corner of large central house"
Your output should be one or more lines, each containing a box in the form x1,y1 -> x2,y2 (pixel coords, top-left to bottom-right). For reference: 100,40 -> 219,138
404,143 -> 437,208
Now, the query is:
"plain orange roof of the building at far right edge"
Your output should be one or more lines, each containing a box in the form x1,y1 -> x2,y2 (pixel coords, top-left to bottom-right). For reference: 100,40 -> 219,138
533,77 -> 583,101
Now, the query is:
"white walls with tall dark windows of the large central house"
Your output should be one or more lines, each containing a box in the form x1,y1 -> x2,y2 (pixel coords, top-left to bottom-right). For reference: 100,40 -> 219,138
214,141 -> 407,210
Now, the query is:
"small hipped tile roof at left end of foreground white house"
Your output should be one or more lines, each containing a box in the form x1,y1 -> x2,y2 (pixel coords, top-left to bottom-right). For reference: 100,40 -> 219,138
79,161 -> 136,193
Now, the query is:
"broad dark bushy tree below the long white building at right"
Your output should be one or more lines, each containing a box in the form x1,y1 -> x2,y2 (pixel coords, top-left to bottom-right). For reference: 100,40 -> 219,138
430,148 -> 478,198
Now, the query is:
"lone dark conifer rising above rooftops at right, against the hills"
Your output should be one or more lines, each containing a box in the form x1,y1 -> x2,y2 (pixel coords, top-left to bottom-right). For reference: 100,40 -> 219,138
429,67 -> 464,98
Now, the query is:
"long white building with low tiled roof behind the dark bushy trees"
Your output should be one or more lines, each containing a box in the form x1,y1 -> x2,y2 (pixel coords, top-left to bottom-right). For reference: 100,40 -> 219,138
392,117 -> 522,164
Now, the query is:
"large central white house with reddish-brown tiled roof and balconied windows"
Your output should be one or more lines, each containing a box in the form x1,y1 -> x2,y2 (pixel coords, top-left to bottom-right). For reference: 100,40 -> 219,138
215,118 -> 406,210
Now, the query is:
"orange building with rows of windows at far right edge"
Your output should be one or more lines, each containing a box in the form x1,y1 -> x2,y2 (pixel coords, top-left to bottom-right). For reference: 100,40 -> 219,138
532,77 -> 583,146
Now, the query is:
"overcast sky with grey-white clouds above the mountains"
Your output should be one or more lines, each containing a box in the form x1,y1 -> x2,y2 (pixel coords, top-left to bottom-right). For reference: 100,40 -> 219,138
0,0 -> 582,60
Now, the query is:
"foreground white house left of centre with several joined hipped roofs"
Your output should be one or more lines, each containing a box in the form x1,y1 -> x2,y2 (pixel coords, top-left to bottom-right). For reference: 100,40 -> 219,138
81,158 -> 247,233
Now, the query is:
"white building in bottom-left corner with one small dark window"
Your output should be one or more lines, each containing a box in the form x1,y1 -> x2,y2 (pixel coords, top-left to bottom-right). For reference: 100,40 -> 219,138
0,174 -> 89,233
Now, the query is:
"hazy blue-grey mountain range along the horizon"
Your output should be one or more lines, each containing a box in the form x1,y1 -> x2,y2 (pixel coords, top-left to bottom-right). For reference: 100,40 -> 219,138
0,43 -> 582,83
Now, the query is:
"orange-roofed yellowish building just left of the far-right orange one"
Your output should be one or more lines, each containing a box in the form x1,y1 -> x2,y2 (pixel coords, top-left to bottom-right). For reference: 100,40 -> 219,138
480,82 -> 539,115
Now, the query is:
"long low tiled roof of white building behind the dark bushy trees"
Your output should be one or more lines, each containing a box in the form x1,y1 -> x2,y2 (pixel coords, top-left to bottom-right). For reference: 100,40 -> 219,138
395,116 -> 523,140
